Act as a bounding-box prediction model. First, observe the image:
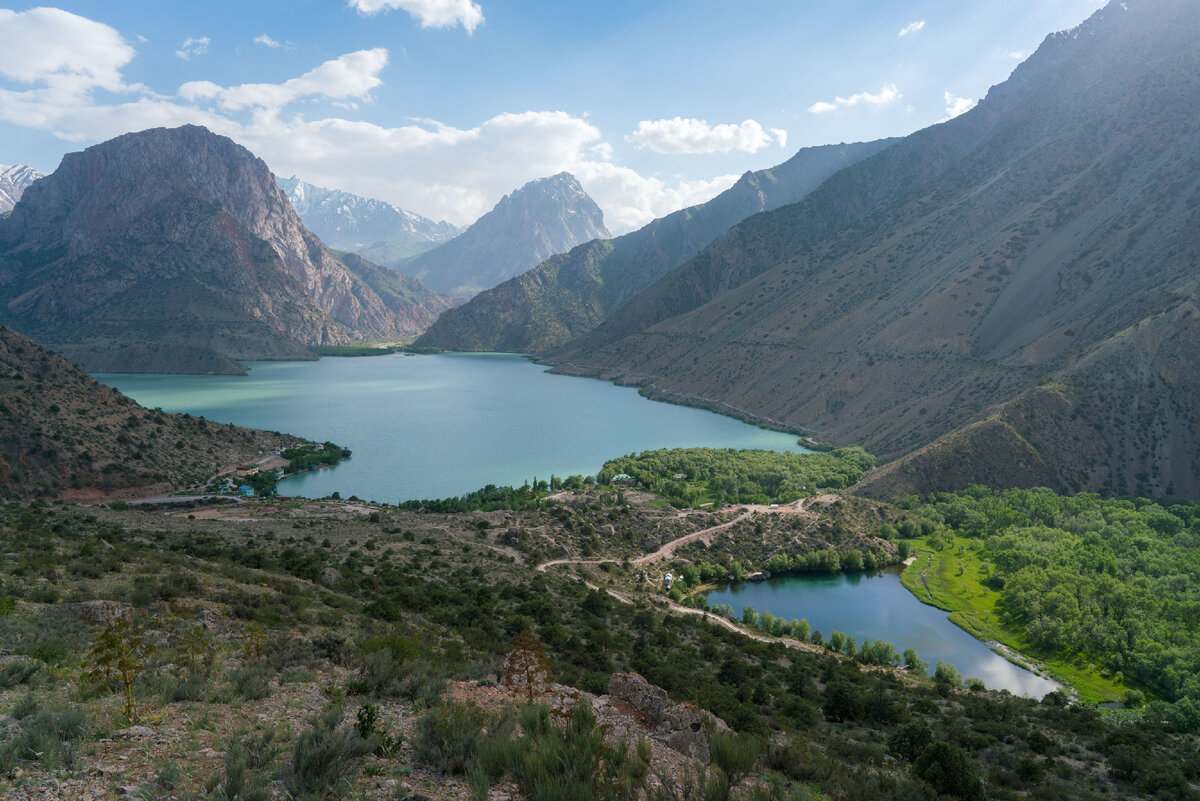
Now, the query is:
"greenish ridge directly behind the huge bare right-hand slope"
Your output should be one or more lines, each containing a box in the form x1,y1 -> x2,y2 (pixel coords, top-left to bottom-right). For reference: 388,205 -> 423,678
421,139 -> 893,353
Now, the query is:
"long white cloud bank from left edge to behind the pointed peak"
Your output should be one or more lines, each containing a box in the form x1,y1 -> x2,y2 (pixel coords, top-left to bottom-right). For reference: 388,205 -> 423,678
0,12 -> 729,233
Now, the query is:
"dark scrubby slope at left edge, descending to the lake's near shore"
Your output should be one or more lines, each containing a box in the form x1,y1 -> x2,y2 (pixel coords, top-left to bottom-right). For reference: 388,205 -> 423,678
0,326 -> 295,498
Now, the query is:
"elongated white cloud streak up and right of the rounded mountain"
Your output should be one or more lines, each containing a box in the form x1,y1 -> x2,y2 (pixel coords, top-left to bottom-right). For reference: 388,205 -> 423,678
179,48 -> 388,112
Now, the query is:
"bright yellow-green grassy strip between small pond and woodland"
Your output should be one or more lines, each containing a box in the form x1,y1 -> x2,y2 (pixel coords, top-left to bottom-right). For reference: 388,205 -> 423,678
900,537 -> 1126,703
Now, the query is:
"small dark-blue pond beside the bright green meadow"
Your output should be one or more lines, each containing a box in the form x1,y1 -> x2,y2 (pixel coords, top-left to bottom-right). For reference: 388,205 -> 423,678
707,568 -> 1060,698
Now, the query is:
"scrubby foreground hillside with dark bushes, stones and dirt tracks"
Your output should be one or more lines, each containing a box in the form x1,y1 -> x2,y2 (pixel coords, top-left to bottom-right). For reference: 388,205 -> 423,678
0,488 -> 1196,801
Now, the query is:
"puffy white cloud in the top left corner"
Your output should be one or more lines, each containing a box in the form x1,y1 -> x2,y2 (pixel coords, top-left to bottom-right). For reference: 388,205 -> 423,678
0,8 -> 134,94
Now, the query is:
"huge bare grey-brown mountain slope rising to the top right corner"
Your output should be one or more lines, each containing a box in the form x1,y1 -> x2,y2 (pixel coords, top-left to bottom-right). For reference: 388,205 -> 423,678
552,0 -> 1200,495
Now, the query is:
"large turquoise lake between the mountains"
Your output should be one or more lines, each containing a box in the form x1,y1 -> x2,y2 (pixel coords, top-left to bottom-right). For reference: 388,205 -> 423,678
96,354 -> 804,504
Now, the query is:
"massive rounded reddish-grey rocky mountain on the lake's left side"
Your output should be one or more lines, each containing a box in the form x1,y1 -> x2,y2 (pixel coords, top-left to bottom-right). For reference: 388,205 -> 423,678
0,126 -> 449,372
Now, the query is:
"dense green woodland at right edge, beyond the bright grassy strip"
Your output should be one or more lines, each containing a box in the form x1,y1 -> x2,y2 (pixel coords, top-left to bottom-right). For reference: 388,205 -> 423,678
913,487 -> 1200,730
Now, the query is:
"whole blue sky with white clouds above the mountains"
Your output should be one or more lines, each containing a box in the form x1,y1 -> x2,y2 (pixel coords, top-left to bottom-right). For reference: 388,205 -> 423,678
0,0 -> 1100,234
